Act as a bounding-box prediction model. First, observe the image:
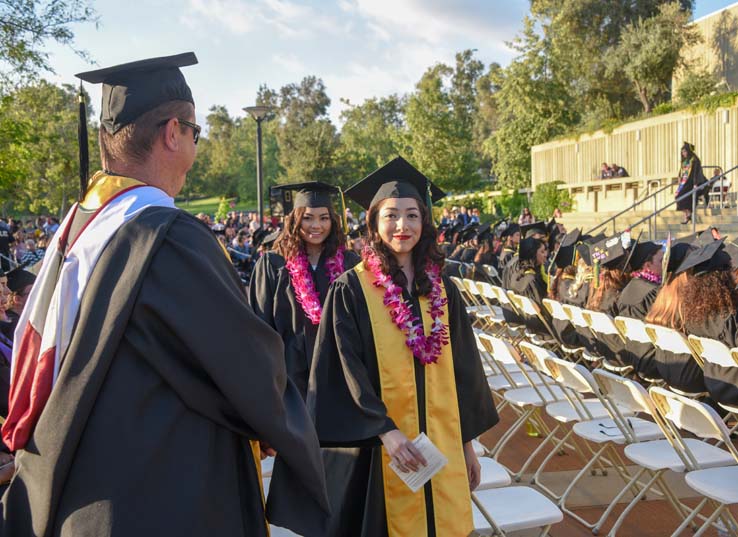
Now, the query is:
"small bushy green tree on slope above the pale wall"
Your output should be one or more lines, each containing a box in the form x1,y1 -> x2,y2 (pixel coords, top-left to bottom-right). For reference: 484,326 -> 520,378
606,2 -> 700,112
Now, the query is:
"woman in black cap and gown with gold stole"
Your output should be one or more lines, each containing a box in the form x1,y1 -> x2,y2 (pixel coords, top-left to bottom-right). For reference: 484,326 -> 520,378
307,157 -> 498,537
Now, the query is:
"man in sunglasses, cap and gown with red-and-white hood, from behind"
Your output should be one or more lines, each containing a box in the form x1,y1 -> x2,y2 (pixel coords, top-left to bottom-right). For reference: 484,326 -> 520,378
0,53 -> 328,537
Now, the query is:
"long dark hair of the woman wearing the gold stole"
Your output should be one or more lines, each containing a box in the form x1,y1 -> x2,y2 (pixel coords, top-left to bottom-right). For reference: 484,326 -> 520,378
364,200 -> 444,296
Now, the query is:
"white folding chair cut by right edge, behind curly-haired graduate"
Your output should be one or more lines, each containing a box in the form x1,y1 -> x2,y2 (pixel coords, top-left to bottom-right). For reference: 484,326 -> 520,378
687,335 -> 738,433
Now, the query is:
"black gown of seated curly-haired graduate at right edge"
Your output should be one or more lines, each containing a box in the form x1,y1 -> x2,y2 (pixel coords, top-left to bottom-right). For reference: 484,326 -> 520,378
687,313 -> 738,405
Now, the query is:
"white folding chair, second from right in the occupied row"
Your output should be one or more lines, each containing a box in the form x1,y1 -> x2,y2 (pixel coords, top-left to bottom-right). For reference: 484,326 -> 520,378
646,323 -> 709,399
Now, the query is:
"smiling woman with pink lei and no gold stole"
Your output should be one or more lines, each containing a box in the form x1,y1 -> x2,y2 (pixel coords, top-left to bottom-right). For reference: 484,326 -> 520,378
249,182 -> 359,399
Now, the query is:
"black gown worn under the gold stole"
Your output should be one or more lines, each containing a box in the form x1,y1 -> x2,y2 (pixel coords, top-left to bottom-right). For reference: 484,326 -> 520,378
308,271 -> 498,537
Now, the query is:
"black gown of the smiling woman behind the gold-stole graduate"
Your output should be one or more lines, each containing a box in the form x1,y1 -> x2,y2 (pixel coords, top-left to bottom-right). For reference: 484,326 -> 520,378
249,250 -> 359,399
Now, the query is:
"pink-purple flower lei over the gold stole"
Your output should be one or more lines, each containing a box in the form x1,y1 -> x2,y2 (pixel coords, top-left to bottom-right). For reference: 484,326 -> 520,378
363,248 -> 449,365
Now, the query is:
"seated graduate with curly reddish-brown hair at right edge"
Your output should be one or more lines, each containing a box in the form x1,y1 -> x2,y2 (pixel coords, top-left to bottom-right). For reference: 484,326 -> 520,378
646,240 -> 738,405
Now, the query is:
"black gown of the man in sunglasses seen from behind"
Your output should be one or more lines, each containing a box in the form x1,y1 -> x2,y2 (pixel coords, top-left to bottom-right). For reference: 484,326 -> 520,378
0,207 -> 328,537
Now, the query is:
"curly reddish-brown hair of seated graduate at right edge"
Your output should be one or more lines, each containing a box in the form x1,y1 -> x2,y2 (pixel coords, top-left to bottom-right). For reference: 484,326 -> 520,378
678,270 -> 738,327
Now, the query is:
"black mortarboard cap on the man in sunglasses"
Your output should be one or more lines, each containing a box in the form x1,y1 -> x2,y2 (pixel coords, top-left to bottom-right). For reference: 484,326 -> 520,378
76,52 -> 197,134
